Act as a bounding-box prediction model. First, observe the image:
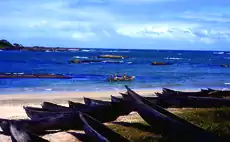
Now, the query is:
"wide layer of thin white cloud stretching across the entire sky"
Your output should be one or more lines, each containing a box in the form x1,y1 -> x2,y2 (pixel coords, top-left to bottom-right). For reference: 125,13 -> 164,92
0,0 -> 230,44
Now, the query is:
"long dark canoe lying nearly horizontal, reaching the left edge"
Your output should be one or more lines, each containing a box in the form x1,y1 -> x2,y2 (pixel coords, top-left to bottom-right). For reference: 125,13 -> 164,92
0,113 -> 82,135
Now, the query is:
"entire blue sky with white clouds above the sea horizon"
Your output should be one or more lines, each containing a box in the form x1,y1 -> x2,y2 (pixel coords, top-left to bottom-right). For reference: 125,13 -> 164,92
0,0 -> 230,50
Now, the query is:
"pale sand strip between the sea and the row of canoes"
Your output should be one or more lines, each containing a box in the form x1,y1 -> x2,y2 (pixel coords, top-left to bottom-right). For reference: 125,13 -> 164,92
0,89 -> 159,119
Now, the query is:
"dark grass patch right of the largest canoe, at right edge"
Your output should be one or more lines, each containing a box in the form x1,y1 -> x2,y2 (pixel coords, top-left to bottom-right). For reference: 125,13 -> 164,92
178,108 -> 230,139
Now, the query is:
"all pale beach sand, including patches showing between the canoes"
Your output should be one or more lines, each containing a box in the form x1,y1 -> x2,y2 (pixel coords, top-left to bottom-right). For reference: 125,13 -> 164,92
0,90 -> 158,142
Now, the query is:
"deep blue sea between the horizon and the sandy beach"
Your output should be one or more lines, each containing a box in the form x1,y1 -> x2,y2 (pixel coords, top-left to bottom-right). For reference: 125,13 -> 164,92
0,49 -> 230,94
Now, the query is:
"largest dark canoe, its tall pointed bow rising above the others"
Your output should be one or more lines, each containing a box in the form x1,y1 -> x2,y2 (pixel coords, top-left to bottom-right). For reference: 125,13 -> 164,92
126,86 -> 221,142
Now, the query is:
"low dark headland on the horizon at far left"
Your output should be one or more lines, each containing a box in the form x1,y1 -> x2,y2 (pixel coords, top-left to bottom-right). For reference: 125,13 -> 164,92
0,39 -> 80,52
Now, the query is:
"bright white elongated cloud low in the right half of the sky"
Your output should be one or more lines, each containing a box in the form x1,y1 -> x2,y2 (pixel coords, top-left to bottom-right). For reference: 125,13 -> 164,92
116,23 -> 230,44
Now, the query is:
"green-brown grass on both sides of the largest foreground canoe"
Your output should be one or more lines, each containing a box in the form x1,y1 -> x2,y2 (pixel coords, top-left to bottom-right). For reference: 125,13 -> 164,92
108,108 -> 230,142
